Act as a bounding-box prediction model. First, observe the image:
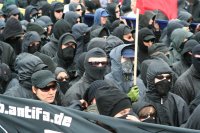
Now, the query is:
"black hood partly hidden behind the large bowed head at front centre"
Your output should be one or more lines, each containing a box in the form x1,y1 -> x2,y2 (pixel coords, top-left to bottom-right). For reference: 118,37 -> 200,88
83,80 -> 109,105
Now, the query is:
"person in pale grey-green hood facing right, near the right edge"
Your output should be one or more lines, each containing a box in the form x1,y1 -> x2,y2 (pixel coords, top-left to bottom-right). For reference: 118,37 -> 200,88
169,29 -> 193,63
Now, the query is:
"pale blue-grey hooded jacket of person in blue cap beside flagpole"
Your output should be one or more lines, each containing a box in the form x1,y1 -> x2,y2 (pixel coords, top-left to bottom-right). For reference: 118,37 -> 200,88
105,44 -> 146,96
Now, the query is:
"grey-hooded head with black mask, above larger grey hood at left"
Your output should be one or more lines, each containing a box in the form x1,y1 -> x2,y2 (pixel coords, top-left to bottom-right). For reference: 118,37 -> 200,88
22,31 -> 41,54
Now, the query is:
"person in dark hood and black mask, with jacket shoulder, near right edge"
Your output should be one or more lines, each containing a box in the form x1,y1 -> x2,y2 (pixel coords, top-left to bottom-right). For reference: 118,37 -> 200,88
172,39 -> 199,77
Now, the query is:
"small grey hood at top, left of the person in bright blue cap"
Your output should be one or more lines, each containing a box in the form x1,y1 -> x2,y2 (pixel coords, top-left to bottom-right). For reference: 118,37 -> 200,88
64,11 -> 81,27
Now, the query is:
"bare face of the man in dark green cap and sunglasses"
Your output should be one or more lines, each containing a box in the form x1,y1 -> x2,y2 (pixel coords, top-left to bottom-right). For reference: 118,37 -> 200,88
32,82 -> 57,103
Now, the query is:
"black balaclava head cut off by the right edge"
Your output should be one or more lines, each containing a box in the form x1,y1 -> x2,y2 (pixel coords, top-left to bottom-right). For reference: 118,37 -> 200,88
192,44 -> 200,73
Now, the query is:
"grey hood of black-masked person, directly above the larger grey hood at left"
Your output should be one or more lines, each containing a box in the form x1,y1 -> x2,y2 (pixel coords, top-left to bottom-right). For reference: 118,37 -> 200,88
22,31 -> 41,53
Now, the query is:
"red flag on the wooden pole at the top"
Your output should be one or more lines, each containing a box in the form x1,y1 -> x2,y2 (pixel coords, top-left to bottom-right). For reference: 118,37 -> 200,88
136,0 -> 177,20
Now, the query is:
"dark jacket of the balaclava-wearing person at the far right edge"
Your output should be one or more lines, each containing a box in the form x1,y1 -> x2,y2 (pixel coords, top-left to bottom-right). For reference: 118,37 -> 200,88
173,65 -> 200,104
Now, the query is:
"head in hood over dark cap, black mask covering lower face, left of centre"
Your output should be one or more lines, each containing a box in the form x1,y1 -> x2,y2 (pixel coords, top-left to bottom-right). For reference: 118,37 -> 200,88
57,33 -> 76,66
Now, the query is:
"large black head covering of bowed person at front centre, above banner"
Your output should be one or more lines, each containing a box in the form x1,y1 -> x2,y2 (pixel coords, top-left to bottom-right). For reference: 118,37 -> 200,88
95,86 -> 132,117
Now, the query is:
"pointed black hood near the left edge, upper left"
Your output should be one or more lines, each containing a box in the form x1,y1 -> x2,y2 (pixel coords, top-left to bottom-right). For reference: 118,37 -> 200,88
3,18 -> 23,40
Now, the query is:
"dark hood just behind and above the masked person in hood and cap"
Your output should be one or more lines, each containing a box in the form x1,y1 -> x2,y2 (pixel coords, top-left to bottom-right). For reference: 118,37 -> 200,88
53,19 -> 71,40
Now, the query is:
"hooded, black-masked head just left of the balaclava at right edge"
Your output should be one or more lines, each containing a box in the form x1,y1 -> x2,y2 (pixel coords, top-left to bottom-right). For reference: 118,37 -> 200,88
181,39 -> 199,66
